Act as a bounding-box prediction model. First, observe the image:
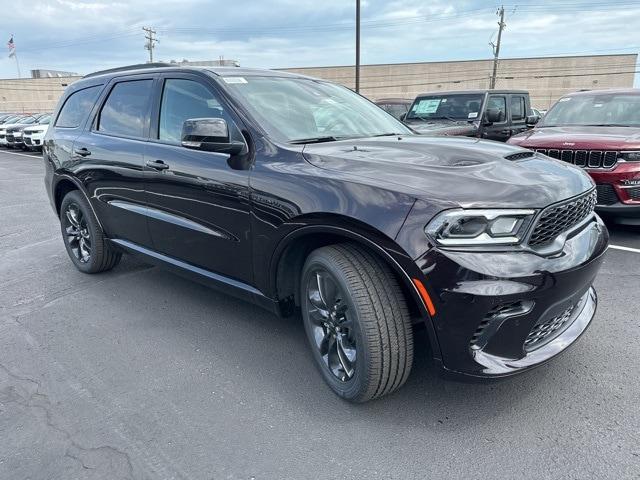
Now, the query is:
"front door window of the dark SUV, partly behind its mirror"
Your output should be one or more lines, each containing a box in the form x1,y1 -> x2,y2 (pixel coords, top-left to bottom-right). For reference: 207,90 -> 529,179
158,78 -> 239,142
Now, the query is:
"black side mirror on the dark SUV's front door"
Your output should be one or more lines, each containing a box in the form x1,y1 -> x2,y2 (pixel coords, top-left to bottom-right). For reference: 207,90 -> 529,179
181,118 -> 244,155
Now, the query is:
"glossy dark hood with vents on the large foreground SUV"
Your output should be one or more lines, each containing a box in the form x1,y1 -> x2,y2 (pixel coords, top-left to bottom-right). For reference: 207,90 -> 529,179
303,135 -> 593,208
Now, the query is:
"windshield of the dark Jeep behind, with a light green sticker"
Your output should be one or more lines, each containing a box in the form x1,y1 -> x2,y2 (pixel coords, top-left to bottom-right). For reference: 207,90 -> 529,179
406,93 -> 484,120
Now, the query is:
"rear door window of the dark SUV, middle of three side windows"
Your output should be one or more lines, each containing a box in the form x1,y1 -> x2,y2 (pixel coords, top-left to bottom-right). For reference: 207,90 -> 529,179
98,80 -> 153,138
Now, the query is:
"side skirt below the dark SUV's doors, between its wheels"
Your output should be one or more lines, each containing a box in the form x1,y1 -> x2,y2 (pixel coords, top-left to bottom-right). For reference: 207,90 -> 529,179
109,239 -> 282,316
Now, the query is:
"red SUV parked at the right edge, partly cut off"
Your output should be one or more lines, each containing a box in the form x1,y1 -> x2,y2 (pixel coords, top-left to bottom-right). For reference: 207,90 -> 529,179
509,89 -> 640,225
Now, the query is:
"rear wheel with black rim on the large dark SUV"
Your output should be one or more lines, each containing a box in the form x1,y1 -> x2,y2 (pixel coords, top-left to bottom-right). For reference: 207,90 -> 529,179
60,190 -> 122,273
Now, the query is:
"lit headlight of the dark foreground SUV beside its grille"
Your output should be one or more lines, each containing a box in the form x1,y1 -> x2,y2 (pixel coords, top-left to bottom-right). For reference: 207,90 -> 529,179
425,209 -> 535,247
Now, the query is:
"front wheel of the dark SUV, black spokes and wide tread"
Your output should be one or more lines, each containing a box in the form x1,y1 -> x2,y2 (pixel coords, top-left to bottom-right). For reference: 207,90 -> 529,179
300,244 -> 413,402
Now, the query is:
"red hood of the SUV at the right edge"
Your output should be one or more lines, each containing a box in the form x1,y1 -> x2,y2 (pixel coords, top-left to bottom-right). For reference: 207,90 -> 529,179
509,126 -> 640,150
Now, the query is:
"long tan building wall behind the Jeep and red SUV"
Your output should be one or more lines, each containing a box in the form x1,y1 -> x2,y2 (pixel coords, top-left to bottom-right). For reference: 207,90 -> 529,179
284,54 -> 638,109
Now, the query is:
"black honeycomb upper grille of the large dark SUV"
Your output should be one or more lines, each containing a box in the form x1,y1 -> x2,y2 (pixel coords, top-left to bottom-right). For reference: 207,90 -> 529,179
529,190 -> 597,247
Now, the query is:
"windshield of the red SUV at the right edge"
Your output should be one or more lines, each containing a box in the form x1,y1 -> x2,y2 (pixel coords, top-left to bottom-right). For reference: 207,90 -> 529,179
540,94 -> 640,127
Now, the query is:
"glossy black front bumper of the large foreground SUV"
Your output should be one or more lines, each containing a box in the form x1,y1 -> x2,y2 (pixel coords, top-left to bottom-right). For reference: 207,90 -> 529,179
417,216 -> 608,377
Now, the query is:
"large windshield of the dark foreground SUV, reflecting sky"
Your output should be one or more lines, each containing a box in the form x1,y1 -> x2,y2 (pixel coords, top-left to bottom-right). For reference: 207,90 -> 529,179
222,76 -> 411,143
